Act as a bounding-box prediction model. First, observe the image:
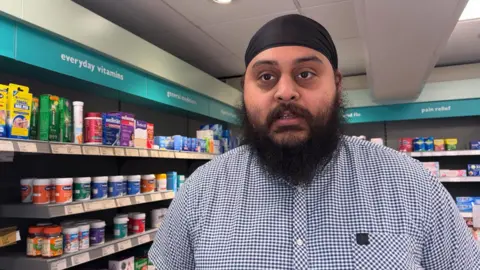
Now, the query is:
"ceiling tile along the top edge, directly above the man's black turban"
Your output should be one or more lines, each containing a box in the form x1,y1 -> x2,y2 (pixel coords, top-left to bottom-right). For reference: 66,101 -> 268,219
163,0 -> 296,26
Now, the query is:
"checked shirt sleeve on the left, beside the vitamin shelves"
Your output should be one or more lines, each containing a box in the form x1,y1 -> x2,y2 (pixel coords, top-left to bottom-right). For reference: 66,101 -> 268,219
148,183 -> 195,270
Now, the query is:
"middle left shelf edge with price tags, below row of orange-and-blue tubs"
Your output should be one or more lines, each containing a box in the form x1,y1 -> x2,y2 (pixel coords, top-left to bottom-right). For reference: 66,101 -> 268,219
0,191 -> 175,219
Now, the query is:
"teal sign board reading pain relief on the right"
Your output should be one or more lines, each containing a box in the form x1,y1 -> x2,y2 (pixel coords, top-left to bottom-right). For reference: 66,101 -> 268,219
345,99 -> 480,124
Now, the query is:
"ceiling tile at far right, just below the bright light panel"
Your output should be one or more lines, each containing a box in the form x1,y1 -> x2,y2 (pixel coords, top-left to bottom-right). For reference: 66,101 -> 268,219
437,20 -> 480,66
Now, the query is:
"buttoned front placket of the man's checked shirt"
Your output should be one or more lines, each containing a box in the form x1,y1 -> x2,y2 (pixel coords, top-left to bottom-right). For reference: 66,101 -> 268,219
292,186 -> 308,270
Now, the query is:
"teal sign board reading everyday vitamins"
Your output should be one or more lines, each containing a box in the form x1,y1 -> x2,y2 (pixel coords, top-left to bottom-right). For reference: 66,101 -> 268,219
16,25 -> 146,97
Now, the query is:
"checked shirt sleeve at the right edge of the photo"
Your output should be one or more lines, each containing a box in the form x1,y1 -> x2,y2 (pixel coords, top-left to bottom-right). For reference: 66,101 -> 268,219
422,176 -> 480,270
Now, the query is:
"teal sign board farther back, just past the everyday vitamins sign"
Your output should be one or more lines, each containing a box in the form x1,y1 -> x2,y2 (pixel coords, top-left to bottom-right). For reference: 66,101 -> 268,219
147,79 -> 210,116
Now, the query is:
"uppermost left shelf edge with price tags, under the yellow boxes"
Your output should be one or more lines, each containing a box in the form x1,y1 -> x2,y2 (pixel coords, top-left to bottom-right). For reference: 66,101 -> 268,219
0,138 -> 216,160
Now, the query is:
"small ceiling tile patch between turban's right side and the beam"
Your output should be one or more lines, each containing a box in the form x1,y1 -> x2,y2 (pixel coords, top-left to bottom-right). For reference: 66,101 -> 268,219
334,38 -> 367,76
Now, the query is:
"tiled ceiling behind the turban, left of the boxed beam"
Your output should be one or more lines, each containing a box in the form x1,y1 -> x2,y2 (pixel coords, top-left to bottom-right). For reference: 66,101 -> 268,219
74,0 -> 365,78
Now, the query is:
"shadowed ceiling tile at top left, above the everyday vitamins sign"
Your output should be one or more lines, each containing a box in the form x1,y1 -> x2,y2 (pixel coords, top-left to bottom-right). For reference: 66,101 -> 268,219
74,0 -> 191,35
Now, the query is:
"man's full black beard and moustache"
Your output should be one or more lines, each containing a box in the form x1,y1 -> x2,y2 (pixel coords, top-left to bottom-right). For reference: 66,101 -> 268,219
242,92 -> 344,186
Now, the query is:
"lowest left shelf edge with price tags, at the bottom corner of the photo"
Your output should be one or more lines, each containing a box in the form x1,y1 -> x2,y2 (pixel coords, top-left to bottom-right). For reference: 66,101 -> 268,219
0,229 -> 158,270
